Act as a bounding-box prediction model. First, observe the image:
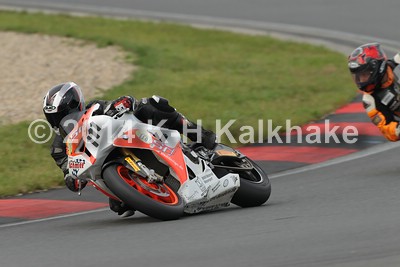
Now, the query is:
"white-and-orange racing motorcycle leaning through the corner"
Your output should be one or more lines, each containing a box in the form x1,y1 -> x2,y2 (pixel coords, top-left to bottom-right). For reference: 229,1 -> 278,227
60,104 -> 271,220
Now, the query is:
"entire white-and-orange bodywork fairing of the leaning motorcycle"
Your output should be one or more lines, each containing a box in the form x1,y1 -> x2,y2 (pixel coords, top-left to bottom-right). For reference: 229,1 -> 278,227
67,109 -> 244,216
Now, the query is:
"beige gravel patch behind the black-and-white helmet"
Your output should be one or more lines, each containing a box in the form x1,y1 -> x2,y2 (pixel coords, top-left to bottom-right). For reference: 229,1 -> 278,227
0,32 -> 135,125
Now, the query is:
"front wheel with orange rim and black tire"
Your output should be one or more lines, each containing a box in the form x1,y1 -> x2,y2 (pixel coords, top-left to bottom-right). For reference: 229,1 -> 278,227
103,164 -> 184,221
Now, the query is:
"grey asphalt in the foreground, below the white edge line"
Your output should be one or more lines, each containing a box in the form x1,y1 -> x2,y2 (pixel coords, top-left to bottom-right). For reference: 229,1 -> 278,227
0,144 -> 400,267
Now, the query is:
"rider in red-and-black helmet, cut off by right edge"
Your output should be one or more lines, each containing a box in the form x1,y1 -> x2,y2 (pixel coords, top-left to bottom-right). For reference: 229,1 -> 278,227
348,43 -> 400,141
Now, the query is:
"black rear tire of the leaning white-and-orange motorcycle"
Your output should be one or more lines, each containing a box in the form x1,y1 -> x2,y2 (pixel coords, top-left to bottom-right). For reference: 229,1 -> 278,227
231,158 -> 271,207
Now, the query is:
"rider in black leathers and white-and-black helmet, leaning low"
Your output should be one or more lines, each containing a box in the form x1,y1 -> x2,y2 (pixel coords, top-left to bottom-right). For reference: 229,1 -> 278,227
43,82 -> 216,217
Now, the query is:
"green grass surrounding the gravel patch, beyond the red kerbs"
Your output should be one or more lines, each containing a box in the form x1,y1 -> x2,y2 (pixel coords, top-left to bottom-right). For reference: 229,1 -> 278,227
0,11 -> 355,196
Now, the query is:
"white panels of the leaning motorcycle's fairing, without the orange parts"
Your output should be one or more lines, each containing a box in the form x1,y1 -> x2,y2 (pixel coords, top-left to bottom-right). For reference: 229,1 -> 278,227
67,109 -> 240,213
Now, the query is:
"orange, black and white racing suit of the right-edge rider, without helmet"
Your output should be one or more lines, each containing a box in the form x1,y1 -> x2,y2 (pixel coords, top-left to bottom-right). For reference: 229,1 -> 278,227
362,60 -> 400,142
